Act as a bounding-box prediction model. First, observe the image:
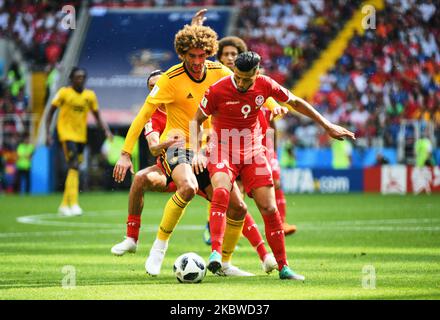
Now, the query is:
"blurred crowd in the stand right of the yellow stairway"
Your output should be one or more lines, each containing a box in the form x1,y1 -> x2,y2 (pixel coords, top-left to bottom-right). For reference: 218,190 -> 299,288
276,0 -> 440,158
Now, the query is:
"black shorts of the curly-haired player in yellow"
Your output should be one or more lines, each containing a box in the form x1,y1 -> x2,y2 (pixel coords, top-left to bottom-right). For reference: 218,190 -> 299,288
157,148 -> 211,190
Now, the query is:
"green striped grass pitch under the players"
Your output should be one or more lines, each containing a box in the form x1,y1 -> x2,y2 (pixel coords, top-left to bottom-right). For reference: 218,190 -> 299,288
0,192 -> 440,299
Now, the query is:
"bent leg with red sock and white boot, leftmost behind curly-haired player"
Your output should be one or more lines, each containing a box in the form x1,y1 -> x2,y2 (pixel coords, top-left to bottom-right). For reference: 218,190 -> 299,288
111,165 -> 167,256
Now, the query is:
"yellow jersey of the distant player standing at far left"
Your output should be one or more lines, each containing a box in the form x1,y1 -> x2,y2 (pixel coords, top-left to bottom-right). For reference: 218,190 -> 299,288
52,87 -> 98,143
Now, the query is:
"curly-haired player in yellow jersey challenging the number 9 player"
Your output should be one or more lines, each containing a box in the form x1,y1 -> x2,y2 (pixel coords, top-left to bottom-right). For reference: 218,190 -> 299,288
113,25 -> 262,276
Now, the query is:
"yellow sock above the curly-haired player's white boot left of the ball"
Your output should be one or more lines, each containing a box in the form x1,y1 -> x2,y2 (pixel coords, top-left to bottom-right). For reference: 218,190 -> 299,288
157,192 -> 188,241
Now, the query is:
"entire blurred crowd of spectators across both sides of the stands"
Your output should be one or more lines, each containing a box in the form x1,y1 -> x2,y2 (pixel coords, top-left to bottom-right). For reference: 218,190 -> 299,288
0,0 -> 440,192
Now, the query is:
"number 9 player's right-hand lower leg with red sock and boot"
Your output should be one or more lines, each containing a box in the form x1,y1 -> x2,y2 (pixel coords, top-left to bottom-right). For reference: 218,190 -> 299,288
252,186 -> 304,280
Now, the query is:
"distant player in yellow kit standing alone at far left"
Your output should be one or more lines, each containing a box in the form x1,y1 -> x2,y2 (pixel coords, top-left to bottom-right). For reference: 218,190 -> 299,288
46,67 -> 113,216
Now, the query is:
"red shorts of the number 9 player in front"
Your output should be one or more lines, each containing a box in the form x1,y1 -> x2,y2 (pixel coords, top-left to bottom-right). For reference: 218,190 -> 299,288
208,152 -> 273,197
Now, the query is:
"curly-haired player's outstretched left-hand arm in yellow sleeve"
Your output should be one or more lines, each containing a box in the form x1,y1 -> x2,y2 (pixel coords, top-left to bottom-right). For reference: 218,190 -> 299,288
113,98 -> 157,182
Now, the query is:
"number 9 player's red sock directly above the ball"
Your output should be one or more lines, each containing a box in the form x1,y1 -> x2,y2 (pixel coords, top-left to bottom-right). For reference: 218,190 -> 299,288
209,188 -> 229,254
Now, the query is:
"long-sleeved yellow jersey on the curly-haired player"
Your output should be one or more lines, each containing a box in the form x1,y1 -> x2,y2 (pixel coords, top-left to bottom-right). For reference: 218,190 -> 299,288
123,60 -> 232,153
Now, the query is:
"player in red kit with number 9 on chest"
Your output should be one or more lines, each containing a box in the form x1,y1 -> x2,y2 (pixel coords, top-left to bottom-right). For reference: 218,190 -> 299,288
192,51 -> 355,280
